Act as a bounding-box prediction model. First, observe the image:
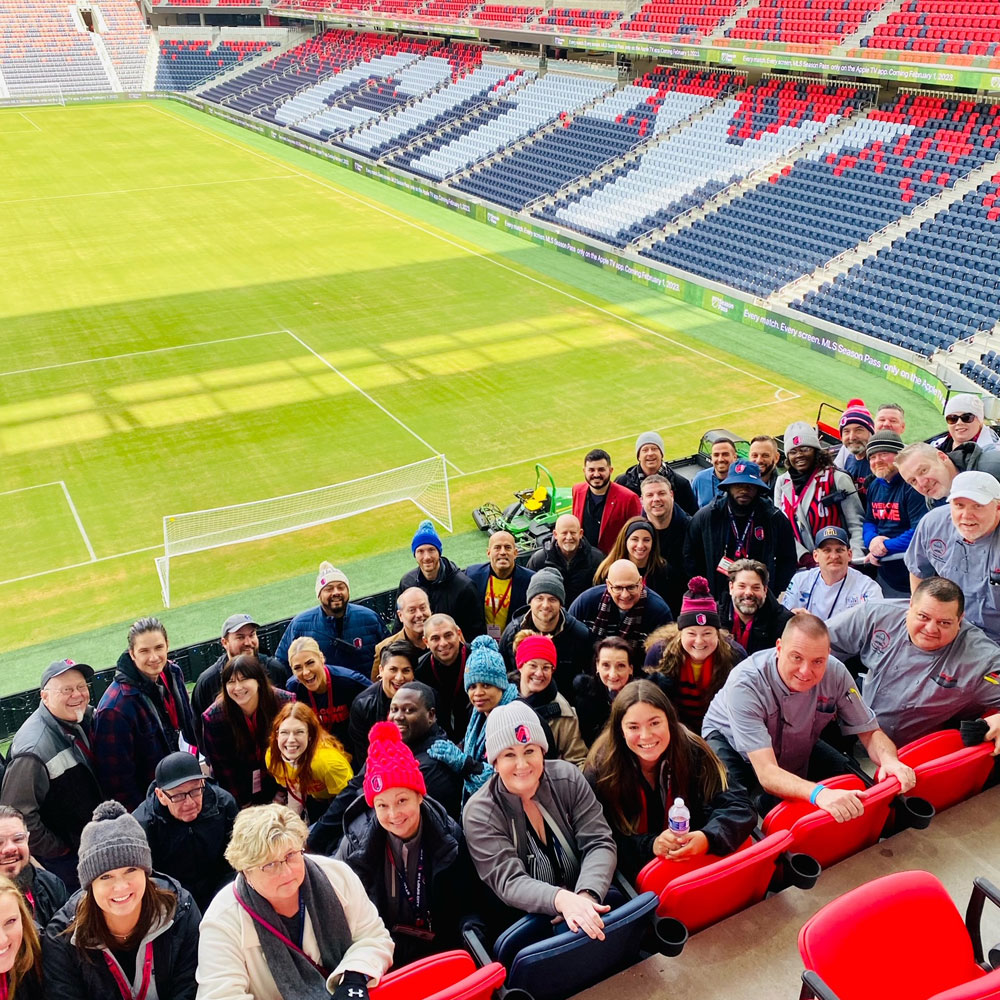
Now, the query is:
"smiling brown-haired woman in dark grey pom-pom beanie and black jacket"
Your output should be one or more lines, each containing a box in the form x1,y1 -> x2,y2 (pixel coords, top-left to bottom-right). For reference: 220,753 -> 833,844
42,801 -> 201,1000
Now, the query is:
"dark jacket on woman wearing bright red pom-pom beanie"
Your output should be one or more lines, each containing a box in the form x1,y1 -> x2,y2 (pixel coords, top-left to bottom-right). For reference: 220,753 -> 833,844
337,795 -> 480,967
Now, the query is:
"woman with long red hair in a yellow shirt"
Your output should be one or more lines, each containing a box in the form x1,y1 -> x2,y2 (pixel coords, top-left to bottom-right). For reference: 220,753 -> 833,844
266,701 -> 354,823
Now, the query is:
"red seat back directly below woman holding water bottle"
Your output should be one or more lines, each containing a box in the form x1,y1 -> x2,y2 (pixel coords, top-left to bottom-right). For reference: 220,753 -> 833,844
656,830 -> 792,934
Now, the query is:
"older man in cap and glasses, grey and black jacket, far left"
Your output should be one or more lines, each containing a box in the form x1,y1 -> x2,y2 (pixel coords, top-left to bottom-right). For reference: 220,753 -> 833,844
0,660 -> 105,891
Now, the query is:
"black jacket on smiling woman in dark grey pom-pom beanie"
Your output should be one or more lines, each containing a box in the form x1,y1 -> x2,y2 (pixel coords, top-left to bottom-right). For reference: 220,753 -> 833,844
42,873 -> 201,1000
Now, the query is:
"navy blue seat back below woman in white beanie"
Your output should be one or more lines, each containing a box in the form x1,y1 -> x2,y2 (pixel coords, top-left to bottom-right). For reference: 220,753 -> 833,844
507,892 -> 656,1000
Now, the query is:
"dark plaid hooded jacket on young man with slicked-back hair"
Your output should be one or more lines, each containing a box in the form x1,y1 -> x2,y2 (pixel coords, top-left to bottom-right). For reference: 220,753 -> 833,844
94,650 -> 197,810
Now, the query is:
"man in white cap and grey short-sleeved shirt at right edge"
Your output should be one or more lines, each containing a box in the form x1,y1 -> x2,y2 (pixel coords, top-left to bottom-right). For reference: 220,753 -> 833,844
906,472 -> 1000,642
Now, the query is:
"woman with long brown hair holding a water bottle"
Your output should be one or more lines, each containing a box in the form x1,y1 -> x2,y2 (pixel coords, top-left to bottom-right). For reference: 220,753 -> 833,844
584,680 -> 757,878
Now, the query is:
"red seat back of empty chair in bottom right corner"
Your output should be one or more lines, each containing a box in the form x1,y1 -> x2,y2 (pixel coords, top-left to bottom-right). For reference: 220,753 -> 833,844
799,871 -> 983,1000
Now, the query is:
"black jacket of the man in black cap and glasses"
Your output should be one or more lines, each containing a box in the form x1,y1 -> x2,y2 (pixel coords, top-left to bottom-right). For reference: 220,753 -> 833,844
133,780 -> 237,910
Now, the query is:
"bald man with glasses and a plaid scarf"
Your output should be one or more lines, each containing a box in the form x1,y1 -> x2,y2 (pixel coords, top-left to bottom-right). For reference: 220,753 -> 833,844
569,559 -> 674,663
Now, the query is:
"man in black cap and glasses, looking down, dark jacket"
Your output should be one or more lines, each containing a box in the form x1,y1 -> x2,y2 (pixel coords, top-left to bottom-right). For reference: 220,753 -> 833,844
133,751 -> 237,913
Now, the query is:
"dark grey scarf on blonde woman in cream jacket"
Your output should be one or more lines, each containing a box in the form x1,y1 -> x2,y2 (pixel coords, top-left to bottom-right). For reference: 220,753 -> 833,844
233,857 -> 352,1000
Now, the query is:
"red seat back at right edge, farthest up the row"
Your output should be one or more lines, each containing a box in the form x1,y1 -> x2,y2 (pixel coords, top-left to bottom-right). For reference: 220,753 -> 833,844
899,729 -> 994,812
